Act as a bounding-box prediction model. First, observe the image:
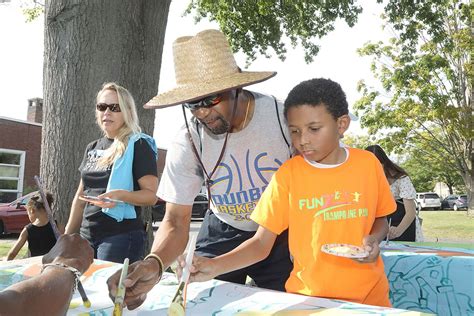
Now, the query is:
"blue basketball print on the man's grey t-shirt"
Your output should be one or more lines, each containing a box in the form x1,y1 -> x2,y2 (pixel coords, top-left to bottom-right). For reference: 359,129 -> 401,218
212,149 -> 282,221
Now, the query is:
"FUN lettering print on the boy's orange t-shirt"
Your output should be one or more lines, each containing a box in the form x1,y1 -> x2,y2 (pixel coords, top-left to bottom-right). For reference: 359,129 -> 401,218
298,191 -> 369,221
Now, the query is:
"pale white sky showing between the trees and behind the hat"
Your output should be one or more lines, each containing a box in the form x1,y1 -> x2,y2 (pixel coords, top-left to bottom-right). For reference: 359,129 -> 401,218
0,0 -> 388,148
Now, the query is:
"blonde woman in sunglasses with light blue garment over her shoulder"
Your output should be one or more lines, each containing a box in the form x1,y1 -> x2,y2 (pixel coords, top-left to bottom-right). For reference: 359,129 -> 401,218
66,82 -> 158,262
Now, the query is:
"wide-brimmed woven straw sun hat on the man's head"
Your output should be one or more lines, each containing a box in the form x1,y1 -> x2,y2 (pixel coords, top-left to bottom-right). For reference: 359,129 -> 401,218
144,30 -> 276,109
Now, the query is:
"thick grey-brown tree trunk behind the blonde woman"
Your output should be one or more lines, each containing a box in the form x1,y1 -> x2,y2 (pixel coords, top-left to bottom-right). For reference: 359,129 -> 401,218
41,0 -> 171,236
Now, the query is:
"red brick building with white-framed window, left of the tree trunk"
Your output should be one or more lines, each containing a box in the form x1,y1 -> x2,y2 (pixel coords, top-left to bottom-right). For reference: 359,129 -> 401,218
0,98 -> 43,203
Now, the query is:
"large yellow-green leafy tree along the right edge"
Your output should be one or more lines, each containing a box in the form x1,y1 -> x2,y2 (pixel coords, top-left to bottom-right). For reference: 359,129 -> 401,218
356,0 -> 474,212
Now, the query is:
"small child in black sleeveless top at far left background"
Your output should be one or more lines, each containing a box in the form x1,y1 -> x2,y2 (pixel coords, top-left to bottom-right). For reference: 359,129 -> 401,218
7,192 -> 56,260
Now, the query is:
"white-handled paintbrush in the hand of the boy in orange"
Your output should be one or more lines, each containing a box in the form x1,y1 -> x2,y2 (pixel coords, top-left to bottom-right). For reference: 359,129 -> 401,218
168,235 -> 196,316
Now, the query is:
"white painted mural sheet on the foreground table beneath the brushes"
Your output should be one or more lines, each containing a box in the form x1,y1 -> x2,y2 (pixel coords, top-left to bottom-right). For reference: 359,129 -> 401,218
0,260 -> 420,316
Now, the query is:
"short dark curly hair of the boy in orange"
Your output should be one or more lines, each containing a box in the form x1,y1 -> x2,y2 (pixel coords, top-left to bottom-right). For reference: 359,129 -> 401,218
284,78 -> 349,119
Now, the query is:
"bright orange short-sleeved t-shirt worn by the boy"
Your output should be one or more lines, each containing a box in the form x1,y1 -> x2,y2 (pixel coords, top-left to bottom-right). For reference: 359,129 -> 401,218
251,148 -> 396,306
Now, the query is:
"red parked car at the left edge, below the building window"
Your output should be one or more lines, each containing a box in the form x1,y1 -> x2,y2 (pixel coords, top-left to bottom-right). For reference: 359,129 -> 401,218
0,191 -> 38,234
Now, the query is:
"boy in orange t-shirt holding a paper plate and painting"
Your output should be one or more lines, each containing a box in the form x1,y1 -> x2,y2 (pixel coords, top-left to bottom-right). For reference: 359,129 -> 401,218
180,79 -> 396,306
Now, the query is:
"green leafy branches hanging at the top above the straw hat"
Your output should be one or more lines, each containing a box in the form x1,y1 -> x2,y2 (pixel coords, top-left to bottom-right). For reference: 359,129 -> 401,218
187,0 -> 362,62
